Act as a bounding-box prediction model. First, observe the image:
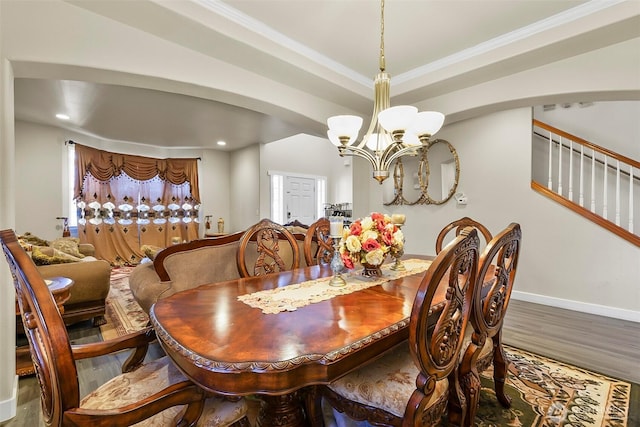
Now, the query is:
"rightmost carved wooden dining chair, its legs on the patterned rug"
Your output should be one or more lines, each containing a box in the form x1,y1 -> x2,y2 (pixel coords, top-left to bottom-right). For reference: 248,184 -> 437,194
454,223 -> 522,426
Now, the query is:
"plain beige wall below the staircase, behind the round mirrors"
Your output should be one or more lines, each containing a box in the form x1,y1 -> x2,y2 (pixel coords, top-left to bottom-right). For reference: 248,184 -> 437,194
370,108 -> 640,321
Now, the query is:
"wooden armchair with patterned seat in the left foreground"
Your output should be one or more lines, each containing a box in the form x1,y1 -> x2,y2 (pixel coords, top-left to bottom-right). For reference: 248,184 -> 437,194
0,230 -> 249,427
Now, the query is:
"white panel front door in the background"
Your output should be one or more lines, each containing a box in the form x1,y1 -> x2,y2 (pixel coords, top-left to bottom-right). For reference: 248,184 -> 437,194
284,176 -> 318,225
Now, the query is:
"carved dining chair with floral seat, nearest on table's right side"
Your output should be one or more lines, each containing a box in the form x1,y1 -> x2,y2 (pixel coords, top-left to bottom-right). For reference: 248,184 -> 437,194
320,227 -> 479,427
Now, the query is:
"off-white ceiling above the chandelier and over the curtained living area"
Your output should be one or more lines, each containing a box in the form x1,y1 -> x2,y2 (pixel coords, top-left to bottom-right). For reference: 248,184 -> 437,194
15,0 -> 640,150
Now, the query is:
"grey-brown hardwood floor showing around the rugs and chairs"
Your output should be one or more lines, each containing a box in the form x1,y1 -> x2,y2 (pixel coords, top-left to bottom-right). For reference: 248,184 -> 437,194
0,300 -> 640,427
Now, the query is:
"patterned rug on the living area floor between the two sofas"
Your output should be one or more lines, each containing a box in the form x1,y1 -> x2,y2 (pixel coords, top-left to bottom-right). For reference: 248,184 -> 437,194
100,267 -> 149,340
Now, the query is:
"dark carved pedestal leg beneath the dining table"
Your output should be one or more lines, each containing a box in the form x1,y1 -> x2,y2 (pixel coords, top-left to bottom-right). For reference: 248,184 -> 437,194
258,392 -> 306,427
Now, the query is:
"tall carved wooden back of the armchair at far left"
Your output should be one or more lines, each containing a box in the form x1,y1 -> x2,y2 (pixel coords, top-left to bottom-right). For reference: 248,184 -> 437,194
0,230 -> 80,426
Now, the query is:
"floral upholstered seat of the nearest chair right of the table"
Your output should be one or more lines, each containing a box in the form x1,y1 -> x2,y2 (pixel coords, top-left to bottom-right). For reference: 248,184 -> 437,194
328,342 -> 449,418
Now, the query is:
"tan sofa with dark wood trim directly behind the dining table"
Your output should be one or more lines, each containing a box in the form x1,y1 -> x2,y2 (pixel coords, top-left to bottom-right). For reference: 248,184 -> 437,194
129,224 -> 316,313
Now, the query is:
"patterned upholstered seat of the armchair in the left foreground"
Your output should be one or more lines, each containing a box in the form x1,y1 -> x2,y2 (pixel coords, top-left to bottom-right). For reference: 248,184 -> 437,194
80,356 -> 248,427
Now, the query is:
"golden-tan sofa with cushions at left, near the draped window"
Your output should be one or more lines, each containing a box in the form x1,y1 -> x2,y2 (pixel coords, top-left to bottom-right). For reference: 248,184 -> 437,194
18,233 -> 111,326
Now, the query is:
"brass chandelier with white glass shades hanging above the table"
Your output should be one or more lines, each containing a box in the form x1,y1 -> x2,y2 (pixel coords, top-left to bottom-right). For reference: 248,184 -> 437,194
327,0 -> 444,184
